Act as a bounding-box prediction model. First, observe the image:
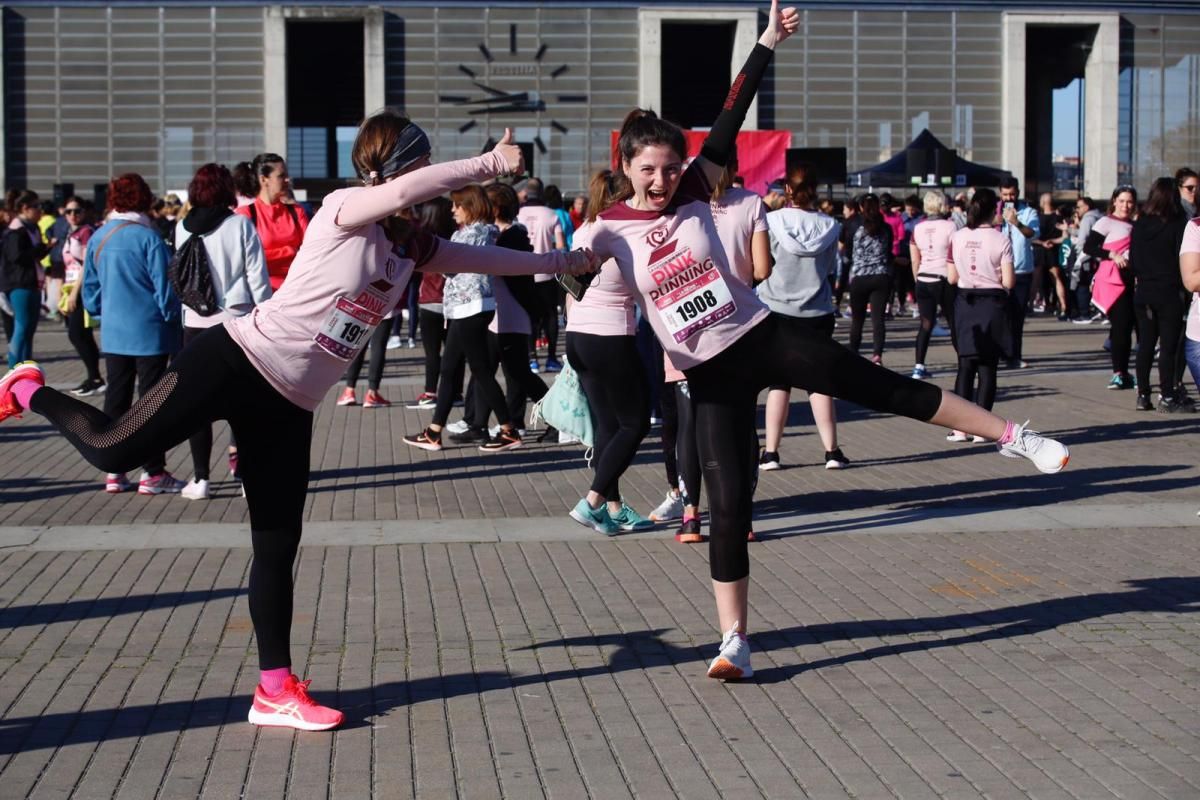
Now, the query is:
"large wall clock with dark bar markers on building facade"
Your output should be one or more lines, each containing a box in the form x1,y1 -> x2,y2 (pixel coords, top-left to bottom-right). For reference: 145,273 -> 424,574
438,24 -> 588,154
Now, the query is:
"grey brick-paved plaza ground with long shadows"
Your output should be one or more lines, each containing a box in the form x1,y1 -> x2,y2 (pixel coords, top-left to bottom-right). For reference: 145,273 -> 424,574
0,318 -> 1200,800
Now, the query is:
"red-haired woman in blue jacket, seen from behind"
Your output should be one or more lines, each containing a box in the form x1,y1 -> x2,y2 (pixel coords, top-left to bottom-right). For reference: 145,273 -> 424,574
83,173 -> 184,494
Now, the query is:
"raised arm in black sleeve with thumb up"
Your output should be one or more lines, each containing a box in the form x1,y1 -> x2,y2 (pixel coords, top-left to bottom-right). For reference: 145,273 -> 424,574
691,0 -> 800,185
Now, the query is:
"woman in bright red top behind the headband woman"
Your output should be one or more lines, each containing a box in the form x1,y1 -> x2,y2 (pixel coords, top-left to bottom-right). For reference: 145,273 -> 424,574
238,152 -> 308,290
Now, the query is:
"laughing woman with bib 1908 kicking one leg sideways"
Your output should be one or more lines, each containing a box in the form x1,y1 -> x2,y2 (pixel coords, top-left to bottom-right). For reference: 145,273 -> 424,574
575,1 -> 1068,679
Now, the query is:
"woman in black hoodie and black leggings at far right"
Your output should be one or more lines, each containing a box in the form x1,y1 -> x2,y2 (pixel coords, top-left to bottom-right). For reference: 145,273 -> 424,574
1129,178 -> 1195,414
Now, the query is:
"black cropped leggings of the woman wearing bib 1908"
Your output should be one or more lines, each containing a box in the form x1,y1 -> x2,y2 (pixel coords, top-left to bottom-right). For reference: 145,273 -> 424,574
685,314 -> 942,582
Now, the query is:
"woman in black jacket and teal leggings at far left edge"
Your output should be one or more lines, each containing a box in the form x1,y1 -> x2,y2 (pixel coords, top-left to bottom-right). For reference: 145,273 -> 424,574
0,191 -> 48,369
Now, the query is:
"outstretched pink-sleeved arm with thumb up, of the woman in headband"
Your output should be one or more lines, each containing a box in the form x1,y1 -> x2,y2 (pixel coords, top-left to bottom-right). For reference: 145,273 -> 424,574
337,128 -> 524,228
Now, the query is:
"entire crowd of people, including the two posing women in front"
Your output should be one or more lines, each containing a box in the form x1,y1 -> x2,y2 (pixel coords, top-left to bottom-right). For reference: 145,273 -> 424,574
0,1 -> 1185,730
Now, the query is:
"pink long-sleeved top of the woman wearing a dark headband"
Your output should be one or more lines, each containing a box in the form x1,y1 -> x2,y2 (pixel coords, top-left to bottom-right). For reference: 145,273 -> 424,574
226,152 -> 580,410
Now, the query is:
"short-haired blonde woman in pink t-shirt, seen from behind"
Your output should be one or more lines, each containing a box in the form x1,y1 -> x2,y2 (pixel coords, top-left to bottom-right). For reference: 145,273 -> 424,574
908,192 -> 958,380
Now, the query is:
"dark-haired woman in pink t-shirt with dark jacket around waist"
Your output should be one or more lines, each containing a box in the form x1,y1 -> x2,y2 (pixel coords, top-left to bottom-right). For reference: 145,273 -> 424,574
946,188 -> 1015,441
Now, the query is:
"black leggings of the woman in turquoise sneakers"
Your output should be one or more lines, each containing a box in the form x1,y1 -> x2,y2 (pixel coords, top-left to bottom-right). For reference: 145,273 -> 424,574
566,331 -> 650,501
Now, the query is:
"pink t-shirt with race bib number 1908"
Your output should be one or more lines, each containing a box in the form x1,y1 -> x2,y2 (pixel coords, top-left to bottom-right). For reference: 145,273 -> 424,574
592,170 -> 768,369
